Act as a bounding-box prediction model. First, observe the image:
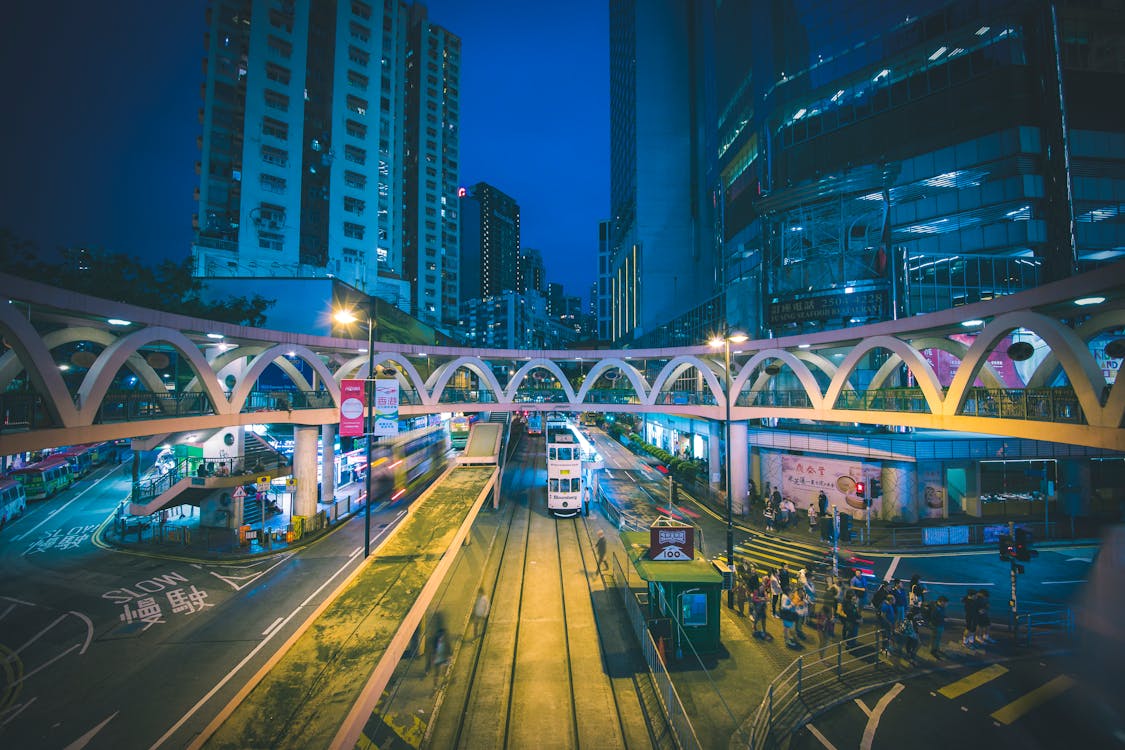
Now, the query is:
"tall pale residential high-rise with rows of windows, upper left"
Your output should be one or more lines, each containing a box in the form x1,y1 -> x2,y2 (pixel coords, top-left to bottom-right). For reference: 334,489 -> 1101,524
191,0 -> 460,326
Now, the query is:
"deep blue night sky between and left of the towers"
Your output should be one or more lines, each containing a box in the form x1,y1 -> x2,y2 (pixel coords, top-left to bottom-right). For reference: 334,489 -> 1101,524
0,0 -> 609,300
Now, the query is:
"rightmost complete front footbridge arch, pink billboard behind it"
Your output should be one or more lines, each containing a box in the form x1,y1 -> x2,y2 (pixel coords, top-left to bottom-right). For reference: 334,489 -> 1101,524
944,310 -> 1106,426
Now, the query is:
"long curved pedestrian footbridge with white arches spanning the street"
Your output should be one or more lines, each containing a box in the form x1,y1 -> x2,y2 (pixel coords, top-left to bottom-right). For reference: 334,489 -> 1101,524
0,263 -> 1125,454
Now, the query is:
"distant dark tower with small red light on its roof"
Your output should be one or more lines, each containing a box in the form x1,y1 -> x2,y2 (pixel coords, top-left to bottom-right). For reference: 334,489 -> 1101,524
461,182 -> 522,299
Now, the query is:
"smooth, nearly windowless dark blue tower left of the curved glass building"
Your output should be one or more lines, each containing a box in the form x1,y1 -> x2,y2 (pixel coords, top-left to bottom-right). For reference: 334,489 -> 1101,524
609,0 -> 718,345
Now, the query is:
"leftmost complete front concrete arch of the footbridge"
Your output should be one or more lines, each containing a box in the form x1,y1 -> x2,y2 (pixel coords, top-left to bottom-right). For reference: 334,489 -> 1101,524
79,326 -> 231,424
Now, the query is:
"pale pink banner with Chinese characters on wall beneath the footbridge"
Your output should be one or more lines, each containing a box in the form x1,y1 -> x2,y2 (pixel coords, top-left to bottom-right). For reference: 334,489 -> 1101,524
781,454 -> 883,515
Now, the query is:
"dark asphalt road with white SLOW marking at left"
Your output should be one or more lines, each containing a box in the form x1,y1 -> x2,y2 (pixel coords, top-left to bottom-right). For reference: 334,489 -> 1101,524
0,466 -> 402,750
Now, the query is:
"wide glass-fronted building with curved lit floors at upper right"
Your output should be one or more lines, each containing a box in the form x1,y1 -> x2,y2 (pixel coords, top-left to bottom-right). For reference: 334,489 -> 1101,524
713,0 -> 1125,335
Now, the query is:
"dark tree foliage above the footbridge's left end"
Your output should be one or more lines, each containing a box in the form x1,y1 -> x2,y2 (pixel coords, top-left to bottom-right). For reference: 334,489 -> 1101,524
0,229 -> 276,326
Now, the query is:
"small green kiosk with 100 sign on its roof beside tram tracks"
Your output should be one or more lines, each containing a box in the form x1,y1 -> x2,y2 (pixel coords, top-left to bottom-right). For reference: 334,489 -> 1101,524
621,518 -> 722,659
